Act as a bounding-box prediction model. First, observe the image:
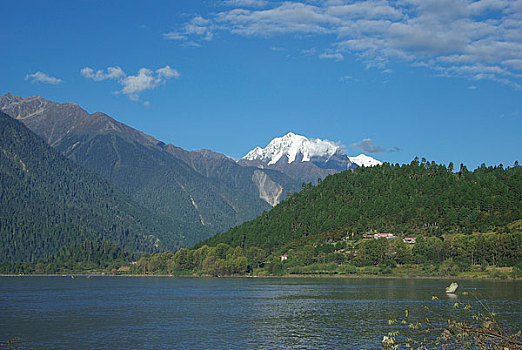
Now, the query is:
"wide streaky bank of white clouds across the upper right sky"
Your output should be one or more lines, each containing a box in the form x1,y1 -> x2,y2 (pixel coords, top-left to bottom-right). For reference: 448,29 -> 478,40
164,0 -> 522,87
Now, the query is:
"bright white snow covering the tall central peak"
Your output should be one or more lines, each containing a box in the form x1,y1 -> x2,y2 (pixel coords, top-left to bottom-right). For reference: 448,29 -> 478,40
243,132 -> 342,165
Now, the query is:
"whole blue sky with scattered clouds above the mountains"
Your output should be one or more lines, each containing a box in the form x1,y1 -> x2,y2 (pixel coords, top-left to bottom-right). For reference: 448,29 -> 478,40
0,0 -> 522,168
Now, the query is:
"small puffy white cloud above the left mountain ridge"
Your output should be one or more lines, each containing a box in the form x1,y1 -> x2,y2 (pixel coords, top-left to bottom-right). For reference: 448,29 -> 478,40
80,65 -> 179,100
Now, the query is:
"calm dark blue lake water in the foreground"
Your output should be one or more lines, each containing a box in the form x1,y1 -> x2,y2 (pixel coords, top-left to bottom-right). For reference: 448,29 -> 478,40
0,277 -> 522,349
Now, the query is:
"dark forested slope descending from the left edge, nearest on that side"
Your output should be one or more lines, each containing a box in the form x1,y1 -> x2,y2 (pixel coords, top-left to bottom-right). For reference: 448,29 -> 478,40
0,112 -> 183,262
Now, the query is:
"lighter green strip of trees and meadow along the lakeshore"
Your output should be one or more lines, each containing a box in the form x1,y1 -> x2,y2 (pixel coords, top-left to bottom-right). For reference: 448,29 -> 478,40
124,232 -> 522,278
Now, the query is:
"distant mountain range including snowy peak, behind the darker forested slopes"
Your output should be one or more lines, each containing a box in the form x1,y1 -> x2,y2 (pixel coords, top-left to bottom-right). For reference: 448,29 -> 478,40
0,93 -> 380,256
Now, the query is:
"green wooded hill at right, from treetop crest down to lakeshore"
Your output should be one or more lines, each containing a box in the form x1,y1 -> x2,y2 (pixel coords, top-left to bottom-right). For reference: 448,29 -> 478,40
126,160 -> 522,278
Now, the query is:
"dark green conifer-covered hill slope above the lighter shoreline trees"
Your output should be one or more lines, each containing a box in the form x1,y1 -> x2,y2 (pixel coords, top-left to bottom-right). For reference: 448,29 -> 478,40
197,160 -> 522,251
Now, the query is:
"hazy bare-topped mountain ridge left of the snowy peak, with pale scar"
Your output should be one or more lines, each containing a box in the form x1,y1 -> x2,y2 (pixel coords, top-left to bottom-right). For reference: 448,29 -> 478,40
0,94 -> 298,249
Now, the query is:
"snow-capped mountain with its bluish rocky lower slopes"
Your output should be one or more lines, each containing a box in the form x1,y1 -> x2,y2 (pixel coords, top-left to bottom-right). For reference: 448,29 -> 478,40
238,132 -> 381,182
